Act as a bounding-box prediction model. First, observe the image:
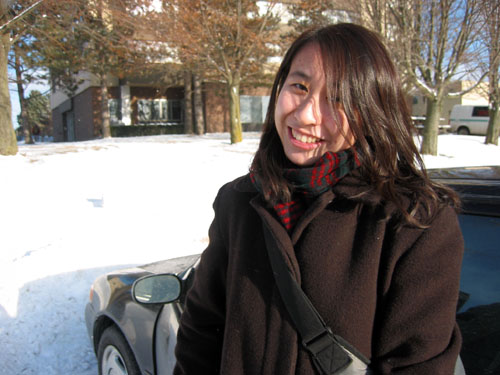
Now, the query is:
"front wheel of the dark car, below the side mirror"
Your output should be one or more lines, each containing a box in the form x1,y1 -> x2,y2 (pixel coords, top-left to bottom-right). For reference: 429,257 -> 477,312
97,326 -> 141,375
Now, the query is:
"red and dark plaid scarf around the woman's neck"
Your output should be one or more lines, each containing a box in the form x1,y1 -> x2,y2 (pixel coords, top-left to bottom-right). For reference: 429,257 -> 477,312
251,148 -> 360,231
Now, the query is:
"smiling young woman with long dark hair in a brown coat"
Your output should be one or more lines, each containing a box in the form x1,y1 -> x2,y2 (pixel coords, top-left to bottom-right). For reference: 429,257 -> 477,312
174,24 -> 463,375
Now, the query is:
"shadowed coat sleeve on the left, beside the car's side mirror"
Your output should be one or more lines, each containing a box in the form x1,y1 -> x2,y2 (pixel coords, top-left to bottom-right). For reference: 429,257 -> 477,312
174,192 -> 227,375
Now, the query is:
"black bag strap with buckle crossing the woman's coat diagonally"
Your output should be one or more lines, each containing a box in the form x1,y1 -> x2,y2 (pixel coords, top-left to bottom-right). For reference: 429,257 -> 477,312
262,222 -> 352,375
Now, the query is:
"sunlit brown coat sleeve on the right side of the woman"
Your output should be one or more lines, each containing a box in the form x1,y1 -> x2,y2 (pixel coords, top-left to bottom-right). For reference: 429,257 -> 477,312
372,207 -> 464,375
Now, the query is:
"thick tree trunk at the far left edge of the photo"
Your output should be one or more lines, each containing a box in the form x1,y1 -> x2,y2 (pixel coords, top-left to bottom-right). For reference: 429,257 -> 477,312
0,32 -> 17,155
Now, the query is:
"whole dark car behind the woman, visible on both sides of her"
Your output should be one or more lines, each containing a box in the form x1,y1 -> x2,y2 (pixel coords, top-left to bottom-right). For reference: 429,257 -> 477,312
85,167 -> 500,375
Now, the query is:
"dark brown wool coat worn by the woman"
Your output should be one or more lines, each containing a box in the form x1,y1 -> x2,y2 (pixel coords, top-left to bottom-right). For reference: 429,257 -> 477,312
174,172 -> 463,375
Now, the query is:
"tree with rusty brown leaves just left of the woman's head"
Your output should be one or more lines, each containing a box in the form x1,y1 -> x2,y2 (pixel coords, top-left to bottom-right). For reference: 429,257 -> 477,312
148,0 -> 279,143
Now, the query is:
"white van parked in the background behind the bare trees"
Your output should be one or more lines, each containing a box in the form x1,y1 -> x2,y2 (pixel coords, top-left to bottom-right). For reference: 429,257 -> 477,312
450,104 -> 489,135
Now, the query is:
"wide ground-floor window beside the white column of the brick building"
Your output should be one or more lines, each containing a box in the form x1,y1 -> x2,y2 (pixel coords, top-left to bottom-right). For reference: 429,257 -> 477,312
137,99 -> 182,124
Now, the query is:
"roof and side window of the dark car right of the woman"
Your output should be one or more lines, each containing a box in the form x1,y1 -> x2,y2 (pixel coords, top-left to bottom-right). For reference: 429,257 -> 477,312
429,166 -> 500,375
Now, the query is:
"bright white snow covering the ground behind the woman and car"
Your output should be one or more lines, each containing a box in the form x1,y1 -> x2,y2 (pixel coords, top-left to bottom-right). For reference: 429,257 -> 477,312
0,133 -> 500,375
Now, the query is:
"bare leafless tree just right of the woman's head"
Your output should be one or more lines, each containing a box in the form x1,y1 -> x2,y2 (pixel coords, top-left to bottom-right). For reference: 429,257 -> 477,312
390,0 -> 482,155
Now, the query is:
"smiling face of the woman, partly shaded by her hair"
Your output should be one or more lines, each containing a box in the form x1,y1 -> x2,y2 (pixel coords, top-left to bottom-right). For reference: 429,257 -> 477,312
274,43 -> 354,166
